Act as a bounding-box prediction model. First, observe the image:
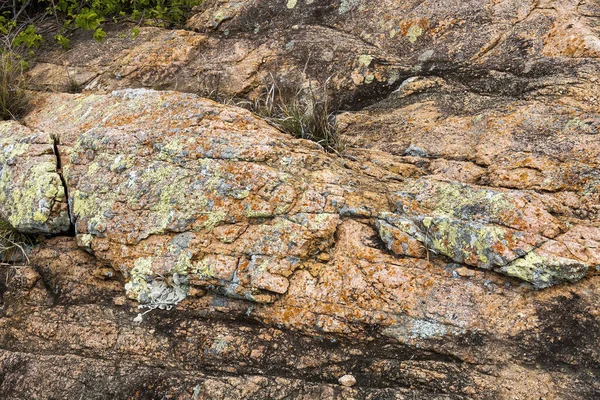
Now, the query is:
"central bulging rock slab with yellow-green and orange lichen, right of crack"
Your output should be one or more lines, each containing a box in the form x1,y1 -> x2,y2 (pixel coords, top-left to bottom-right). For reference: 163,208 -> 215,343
21,90 -> 597,303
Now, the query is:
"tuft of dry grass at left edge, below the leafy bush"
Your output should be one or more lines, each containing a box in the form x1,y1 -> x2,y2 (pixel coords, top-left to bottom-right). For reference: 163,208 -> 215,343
0,51 -> 29,119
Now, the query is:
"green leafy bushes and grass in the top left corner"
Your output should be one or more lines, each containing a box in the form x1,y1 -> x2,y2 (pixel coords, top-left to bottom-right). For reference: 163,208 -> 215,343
0,0 -> 201,119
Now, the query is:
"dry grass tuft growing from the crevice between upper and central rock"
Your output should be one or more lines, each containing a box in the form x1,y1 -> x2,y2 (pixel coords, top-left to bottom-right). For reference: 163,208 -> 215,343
249,76 -> 346,153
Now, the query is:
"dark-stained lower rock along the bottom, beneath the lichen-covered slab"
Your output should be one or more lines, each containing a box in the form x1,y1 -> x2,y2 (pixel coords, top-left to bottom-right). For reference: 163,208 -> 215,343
0,238 -> 600,399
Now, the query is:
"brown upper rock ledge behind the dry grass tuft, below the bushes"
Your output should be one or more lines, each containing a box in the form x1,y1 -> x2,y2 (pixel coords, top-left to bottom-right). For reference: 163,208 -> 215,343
28,0 -> 600,109
